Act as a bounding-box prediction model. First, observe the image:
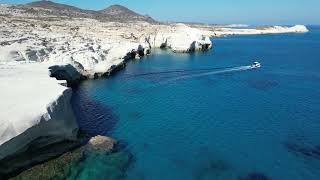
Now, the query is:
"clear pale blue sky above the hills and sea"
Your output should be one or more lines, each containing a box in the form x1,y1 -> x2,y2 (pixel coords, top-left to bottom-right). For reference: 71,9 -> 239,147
0,0 -> 320,25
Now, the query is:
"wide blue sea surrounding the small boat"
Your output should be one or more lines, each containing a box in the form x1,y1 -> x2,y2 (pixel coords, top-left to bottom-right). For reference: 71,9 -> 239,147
73,28 -> 320,180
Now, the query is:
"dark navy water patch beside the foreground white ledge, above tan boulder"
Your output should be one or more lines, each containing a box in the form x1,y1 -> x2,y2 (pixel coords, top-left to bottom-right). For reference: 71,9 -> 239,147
71,85 -> 119,136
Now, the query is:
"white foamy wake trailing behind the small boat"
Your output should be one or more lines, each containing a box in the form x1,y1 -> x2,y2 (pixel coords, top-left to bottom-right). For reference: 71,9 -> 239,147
156,66 -> 254,86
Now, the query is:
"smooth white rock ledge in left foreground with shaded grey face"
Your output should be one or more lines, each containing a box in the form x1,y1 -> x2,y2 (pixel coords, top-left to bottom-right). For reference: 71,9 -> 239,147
0,63 -> 78,159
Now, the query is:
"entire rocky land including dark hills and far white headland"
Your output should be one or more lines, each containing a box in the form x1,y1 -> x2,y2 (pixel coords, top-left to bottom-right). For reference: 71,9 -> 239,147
0,1 -> 308,179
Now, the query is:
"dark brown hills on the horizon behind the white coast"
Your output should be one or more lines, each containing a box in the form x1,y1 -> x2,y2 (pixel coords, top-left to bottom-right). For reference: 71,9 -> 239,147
10,0 -> 157,23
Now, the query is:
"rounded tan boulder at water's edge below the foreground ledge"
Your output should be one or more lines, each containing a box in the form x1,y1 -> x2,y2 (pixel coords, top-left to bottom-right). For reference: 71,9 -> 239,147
86,135 -> 117,153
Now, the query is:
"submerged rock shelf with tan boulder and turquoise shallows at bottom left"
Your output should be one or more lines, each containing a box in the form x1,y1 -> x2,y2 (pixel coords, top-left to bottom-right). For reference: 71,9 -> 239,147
12,136 -> 128,180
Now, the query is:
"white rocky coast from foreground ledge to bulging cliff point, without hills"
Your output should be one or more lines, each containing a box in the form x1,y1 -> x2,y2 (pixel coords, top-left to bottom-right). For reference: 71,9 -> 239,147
0,2 -> 212,163
